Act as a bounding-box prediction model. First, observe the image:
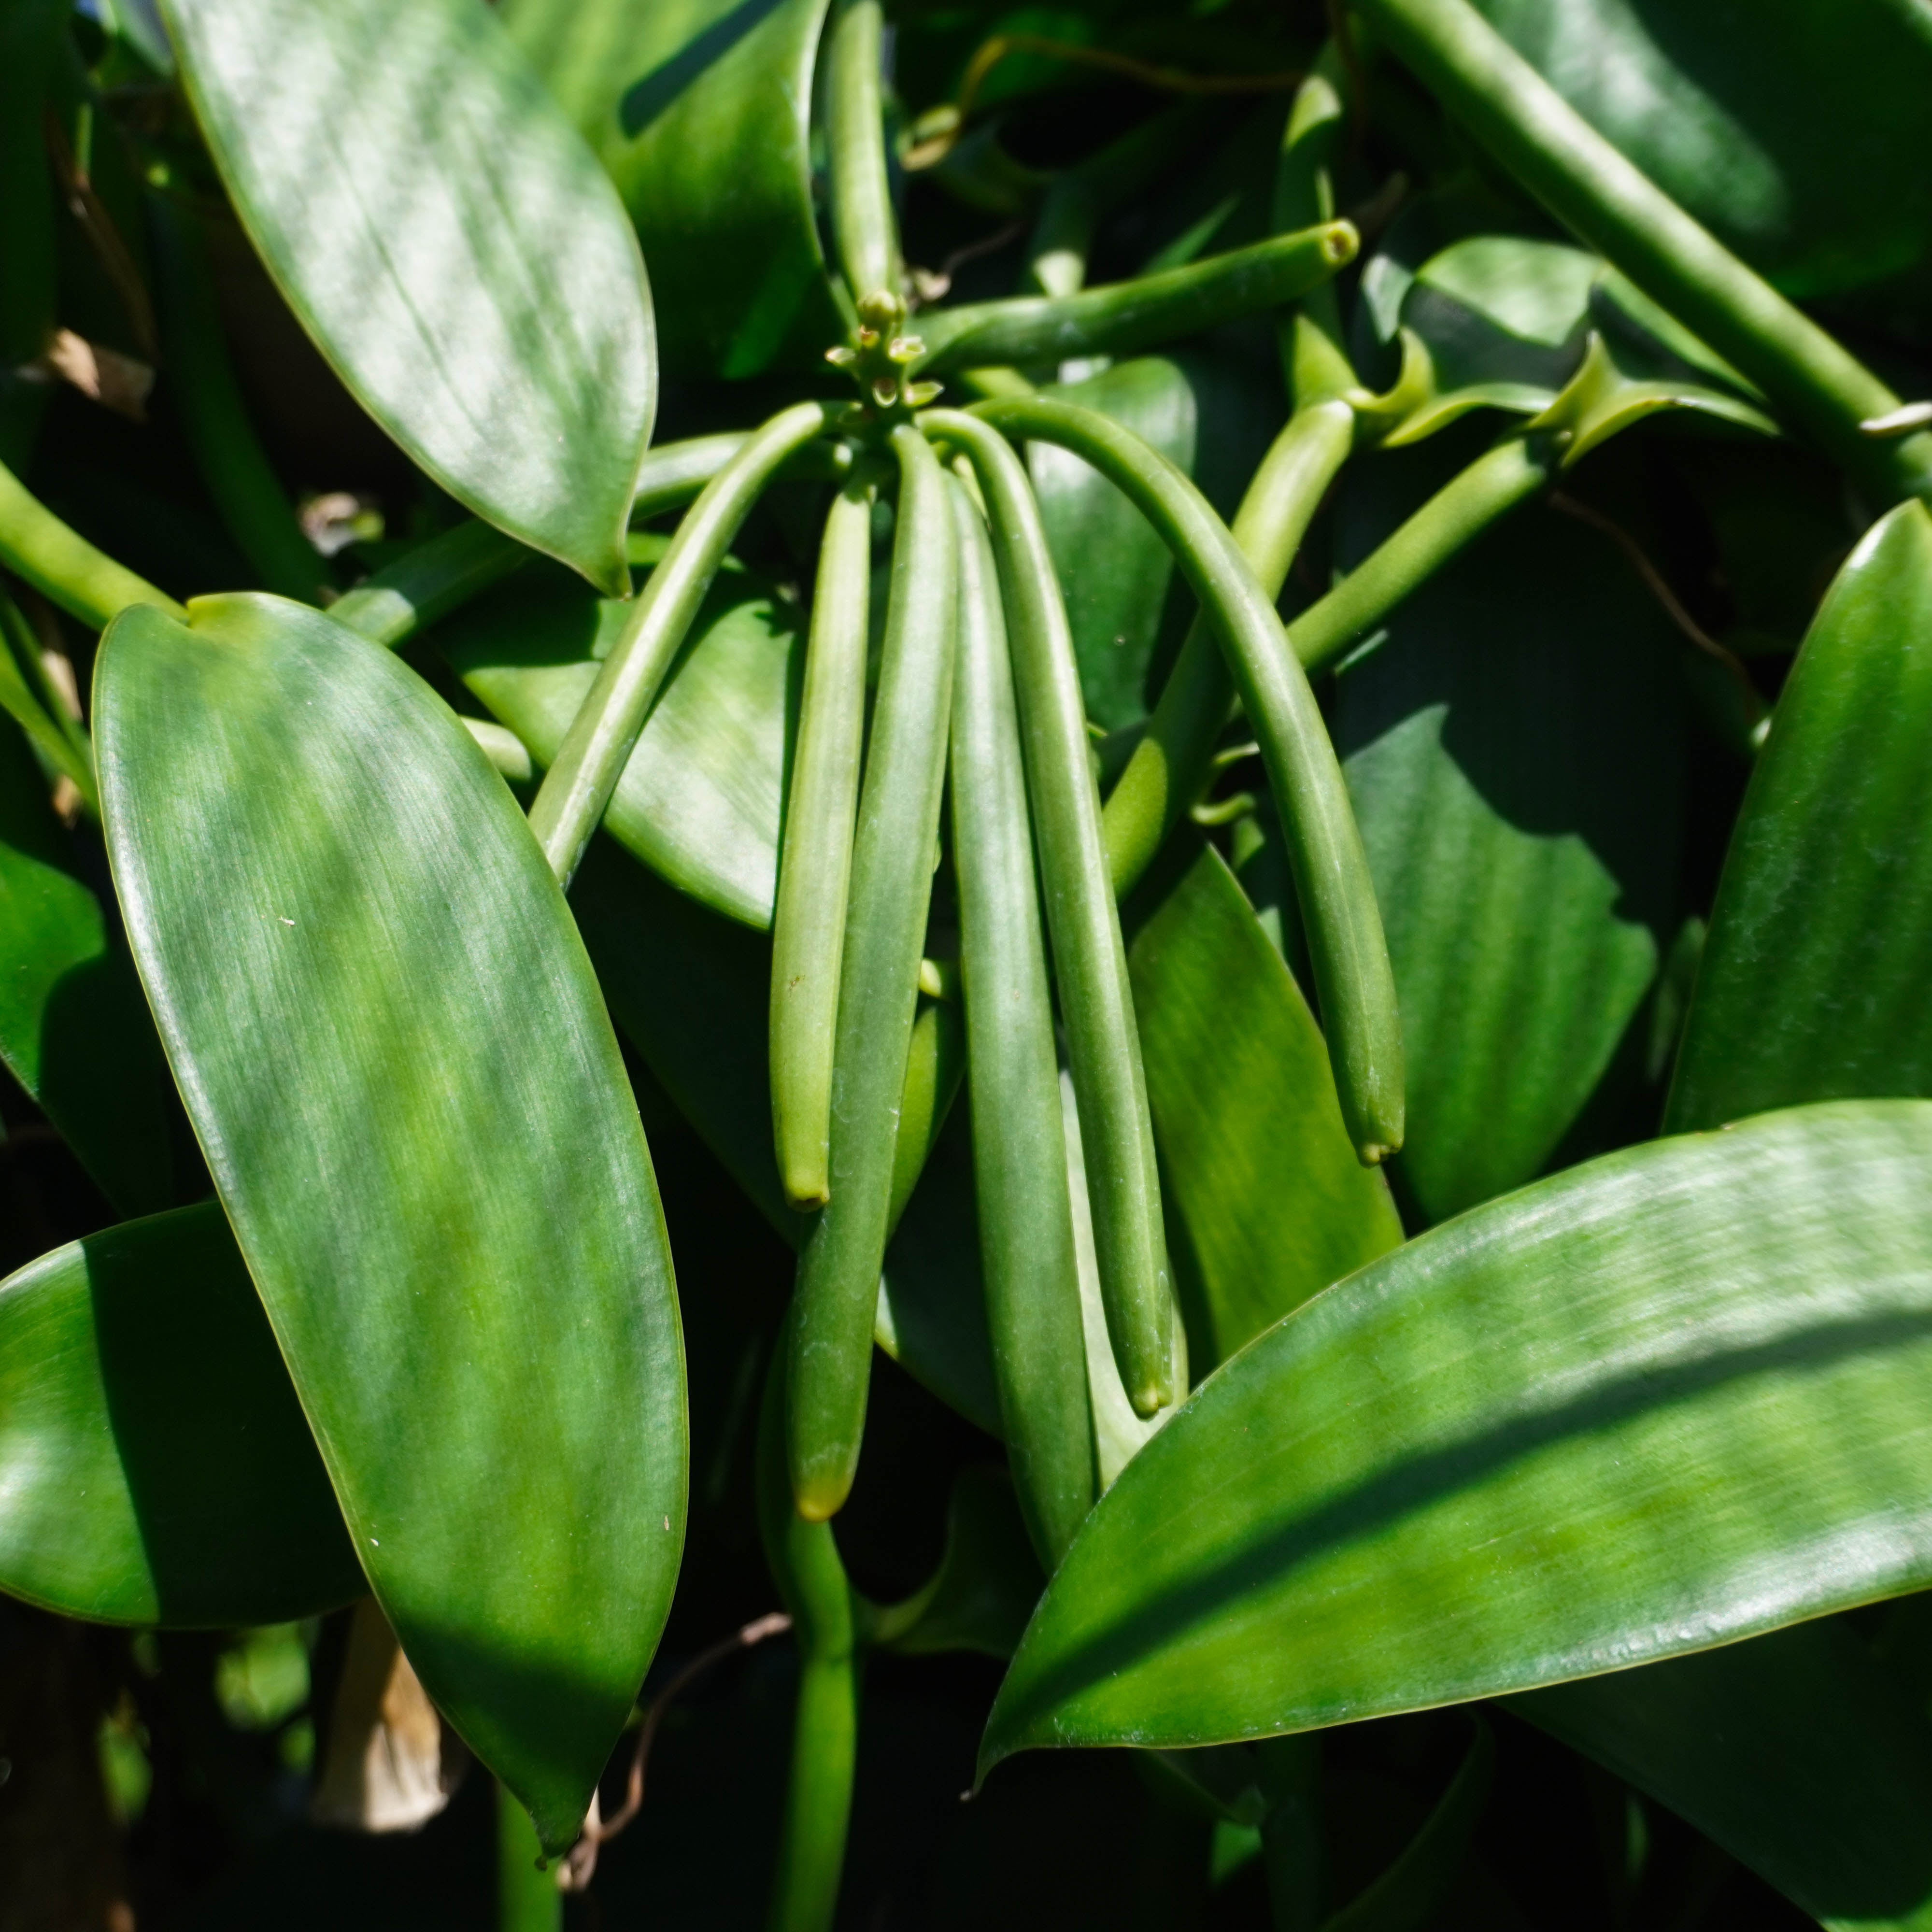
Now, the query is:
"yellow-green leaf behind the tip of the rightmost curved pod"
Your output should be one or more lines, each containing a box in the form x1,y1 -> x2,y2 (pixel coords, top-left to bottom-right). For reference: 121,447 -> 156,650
1126,840 -> 1403,1376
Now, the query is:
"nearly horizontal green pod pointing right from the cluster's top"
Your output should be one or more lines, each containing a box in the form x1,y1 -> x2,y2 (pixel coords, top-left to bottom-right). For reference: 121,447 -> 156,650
916,222 -> 1360,375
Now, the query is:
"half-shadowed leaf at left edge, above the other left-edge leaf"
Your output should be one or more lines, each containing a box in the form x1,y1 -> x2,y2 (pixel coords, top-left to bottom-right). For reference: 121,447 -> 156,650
0,719 -> 172,1213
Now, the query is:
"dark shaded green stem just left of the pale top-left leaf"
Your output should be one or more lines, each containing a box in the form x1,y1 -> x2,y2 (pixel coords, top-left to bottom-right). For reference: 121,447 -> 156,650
147,187 -> 328,603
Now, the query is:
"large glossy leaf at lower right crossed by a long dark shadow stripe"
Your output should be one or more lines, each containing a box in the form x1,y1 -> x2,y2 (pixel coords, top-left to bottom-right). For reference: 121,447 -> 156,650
983,1101 -> 1932,1764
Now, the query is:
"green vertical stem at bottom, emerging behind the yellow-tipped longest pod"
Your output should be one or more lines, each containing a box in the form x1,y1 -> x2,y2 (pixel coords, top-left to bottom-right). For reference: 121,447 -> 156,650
757,1321 -> 860,1932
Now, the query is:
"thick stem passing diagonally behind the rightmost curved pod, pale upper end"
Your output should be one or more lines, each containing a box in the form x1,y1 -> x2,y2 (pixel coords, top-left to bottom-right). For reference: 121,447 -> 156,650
1103,402 -> 1354,896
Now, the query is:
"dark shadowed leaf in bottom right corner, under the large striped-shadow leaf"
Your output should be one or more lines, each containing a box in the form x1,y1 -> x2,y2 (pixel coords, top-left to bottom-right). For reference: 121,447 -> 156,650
1509,1617 -> 1932,1932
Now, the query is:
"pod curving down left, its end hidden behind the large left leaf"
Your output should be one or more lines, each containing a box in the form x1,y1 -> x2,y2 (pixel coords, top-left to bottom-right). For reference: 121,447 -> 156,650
529,402 -> 827,887
